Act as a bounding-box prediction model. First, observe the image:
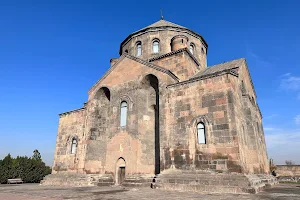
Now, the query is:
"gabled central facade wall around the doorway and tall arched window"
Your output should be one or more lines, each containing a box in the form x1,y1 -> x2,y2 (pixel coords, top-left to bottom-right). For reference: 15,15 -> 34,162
85,58 -> 174,175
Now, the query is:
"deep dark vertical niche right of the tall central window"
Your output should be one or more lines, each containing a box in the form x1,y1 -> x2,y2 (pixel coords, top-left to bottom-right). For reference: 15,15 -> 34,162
145,74 -> 160,174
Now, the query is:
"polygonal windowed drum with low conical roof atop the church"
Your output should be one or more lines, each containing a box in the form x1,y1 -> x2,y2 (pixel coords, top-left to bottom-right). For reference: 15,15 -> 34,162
119,19 -> 208,66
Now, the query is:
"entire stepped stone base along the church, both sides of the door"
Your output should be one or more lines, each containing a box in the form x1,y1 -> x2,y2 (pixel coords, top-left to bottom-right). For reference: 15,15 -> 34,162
41,169 -> 278,193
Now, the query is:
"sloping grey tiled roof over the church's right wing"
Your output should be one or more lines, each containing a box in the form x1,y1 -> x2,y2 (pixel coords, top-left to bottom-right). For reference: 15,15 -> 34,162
193,58 -> 245,78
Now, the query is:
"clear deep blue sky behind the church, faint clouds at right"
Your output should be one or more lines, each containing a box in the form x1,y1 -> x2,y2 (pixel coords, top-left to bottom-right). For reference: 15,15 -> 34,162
0,0 -> 300,165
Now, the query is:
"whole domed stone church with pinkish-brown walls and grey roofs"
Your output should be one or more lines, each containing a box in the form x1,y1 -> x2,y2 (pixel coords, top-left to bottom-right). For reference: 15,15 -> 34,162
45,19 -> 276,192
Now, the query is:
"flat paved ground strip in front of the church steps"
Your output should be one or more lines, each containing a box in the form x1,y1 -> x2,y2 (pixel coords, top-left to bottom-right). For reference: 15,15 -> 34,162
0,184 -> 300,200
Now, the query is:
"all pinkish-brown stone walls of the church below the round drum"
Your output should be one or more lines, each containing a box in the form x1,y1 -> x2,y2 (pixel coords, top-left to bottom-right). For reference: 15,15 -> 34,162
51,56 -> 268,175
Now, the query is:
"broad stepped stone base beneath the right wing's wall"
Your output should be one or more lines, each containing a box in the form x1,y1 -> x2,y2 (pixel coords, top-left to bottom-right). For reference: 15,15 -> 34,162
153,169 -> 277,193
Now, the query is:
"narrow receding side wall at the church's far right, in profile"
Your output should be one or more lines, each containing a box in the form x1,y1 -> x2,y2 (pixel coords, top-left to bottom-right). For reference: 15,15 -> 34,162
231,63 -> 269,173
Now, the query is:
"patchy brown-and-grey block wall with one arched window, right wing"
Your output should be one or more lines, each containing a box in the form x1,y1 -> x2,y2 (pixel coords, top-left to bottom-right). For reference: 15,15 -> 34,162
162,75 -> 241,171
